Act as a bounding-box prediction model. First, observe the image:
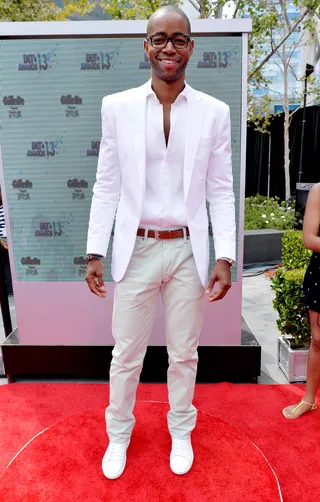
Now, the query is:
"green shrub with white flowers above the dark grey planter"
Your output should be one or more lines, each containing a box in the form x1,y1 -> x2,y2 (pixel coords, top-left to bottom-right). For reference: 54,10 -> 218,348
244,195 -> 294,230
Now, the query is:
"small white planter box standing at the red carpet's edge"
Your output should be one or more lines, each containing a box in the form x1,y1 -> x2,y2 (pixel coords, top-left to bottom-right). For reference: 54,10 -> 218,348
278,336 -> 308,383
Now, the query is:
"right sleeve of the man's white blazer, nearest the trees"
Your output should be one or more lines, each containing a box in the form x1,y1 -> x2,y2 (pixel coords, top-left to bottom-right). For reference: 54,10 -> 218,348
206,103 -> 236,260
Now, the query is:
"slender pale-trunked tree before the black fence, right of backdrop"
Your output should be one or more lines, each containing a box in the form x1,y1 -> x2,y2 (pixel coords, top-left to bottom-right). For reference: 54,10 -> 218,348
242,0 -> 320,199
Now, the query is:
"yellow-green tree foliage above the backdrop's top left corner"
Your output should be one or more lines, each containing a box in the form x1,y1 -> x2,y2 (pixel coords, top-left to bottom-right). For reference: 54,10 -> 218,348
0,0 -> 95,21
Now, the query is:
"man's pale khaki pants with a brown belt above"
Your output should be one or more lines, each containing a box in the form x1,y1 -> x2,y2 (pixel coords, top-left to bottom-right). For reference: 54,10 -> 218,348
106,237 -> 204,443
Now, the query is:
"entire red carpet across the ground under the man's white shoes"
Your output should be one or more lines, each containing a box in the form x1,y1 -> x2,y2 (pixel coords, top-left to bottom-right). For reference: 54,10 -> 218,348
0,384 -> 320,502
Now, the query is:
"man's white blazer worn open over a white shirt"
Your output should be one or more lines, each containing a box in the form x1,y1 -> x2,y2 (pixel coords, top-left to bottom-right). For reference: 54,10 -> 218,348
87,84 -> 236,286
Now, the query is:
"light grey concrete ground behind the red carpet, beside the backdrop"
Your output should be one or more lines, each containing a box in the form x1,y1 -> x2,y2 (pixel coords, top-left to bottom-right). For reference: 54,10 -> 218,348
0,269 -> 288,385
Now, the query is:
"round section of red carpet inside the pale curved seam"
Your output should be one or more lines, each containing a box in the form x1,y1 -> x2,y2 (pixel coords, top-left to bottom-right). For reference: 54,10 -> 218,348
0,402 -> 280,502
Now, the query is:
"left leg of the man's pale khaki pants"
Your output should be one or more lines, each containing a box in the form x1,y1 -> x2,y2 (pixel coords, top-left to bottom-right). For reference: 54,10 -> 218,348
106,238 -> 161,443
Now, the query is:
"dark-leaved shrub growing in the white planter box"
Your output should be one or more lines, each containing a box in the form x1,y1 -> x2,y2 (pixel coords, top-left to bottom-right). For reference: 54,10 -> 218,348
271,268 -> 311,348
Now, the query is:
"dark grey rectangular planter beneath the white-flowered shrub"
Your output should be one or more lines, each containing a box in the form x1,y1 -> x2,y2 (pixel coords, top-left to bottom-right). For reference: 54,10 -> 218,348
243,230 -> 284,266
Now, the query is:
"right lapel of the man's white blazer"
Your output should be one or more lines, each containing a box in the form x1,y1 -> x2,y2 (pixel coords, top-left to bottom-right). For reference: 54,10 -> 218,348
183,86 -> 204,200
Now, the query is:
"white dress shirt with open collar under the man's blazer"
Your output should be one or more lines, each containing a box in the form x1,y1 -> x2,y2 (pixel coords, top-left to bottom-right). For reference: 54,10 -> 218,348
140,84 -> 188,230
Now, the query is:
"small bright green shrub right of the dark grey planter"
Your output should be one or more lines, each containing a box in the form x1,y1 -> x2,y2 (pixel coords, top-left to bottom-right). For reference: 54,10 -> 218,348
282,230 -> 312,270
